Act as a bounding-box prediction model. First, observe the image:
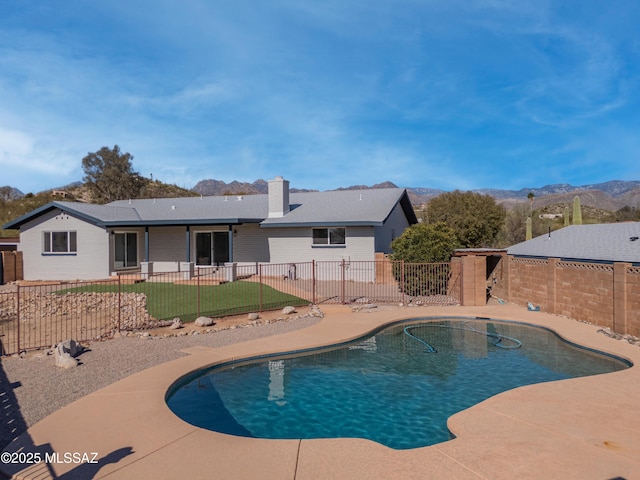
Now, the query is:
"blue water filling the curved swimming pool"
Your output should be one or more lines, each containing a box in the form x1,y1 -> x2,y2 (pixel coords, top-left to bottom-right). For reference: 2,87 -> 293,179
167,319 -> 630,449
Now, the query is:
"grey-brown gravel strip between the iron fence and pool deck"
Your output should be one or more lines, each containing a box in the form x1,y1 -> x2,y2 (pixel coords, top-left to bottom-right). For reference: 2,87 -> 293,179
0,316 -> 320,450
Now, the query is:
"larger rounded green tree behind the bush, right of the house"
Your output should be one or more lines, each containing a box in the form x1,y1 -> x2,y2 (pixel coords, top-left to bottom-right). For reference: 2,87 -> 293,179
427,190 -> 506,248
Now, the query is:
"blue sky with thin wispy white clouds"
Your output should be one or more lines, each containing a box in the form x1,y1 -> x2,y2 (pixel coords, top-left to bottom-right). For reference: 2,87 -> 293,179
0,0 -> 640,193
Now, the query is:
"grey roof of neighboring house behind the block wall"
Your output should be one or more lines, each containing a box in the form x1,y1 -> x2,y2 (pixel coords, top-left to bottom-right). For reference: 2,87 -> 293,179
507,222 -> 640,263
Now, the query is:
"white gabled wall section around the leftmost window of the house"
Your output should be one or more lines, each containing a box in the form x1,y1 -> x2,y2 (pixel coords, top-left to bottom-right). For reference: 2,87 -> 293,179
20,210 -> 109,280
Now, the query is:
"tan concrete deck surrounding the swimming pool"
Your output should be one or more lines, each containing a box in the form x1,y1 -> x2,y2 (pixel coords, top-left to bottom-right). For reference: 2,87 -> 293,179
0,305 -> 640,480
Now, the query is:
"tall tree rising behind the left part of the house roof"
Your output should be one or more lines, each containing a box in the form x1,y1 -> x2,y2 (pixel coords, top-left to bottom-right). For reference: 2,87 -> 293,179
82,145 -> 148,203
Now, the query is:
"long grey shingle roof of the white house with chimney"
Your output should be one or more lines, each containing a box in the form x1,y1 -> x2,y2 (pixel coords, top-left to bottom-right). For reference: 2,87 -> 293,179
3,188 -> 417,229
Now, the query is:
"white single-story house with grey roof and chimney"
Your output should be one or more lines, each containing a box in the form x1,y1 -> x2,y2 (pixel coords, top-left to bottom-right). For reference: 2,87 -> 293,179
3,177 -> 417,280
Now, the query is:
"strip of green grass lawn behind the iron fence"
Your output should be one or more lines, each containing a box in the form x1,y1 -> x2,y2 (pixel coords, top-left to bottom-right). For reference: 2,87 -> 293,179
58,281 -> 309,322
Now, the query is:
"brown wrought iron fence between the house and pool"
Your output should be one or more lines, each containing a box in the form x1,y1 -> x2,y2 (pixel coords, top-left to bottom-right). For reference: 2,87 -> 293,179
0,260 -> 460,355
